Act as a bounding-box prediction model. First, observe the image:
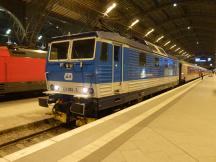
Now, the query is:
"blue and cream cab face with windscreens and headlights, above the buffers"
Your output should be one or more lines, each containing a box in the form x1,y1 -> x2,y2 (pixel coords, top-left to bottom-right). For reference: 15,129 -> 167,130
46,38 -> 95,98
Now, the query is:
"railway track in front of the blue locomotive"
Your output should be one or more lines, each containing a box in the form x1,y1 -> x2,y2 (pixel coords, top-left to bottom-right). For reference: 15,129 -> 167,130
0,118 -> 71,157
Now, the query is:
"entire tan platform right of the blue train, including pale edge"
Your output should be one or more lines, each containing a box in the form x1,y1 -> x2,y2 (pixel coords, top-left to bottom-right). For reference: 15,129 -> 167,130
0,77 -> 216,162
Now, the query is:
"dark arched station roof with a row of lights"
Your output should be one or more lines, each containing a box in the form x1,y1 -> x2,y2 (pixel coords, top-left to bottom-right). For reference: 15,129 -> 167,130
0,0 -> 216,58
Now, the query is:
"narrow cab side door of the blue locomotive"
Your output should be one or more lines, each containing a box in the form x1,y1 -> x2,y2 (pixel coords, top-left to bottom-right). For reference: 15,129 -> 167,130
113,45 -> 123,94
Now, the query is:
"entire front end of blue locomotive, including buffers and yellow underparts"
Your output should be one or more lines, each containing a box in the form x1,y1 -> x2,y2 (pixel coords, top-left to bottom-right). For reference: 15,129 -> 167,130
39,36 -> 97,123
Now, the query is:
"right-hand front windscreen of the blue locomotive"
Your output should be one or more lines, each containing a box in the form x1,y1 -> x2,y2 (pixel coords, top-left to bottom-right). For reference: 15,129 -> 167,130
71,39 -> 95,59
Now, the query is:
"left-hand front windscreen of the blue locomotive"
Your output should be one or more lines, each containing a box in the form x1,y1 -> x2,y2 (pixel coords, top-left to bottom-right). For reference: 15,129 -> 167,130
49,42 -> 69,60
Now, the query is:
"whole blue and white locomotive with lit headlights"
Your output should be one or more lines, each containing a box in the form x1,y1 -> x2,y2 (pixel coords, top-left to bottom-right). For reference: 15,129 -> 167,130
39,31 -> 179,122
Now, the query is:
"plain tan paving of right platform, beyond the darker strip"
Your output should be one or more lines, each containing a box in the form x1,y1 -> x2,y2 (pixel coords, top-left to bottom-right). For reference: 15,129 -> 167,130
102,77 -> 216,162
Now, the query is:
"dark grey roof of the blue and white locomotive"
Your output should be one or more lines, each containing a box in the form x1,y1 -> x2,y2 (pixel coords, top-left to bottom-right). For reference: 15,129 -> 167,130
51,31 -> 168,56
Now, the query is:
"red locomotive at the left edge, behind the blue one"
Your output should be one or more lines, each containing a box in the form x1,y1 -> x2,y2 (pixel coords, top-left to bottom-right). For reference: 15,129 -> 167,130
0,46 -> 46,94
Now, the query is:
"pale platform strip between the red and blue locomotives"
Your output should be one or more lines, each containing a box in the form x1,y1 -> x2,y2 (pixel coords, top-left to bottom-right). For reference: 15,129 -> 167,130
0,98 -> 51,131
